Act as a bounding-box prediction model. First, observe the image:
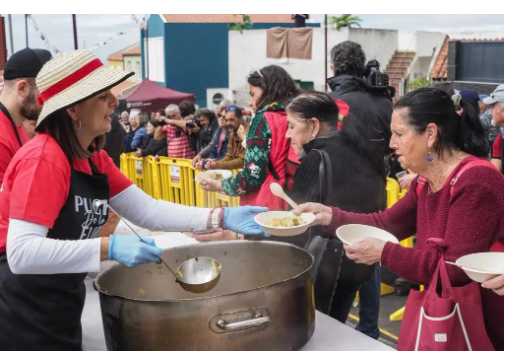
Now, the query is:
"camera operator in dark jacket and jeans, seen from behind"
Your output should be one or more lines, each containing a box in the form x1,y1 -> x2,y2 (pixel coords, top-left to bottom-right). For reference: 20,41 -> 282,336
328,41 -> 393,338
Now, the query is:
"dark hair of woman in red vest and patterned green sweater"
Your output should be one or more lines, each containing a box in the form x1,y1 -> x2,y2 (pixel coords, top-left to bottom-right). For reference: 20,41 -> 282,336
248,65 -> 300,110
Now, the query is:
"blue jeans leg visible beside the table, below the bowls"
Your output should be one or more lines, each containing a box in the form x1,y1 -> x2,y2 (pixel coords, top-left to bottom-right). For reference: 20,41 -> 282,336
356,262 -> 381,339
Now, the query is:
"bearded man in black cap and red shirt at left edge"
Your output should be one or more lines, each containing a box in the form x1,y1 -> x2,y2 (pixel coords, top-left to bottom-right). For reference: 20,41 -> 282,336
0,48 -> 51,184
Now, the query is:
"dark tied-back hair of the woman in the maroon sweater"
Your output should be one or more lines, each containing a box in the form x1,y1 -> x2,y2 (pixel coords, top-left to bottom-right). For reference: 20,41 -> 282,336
395,87 -> 490,157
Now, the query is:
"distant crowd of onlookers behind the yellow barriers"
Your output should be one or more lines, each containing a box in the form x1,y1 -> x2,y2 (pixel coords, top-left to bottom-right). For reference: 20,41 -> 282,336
112,100 -> 255,174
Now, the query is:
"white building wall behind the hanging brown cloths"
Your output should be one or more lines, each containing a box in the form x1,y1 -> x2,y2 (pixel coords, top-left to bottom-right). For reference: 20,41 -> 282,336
229,28 -> 398,94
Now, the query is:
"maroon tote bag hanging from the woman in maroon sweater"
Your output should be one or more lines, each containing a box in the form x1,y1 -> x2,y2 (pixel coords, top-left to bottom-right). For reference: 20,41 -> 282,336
397,238 -> 494,351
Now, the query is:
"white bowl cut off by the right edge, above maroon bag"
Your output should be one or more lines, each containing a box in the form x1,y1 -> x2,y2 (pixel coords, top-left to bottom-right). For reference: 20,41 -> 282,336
455,252 -> 505,283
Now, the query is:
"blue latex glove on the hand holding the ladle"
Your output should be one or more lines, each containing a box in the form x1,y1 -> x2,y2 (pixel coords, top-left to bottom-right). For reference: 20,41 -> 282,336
108,235 -> 163,267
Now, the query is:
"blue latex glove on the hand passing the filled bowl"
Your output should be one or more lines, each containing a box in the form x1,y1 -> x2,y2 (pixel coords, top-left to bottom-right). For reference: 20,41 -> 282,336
223,205 -> 269,236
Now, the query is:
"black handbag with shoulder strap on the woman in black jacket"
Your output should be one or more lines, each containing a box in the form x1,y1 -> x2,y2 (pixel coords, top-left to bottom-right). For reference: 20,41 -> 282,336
304,149 -> 375,314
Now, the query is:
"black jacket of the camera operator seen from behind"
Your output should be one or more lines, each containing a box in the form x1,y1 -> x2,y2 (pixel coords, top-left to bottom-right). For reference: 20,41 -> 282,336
328,75 -> 393,180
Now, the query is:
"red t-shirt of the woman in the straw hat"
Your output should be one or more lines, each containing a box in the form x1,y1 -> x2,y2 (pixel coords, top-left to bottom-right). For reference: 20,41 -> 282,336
0,133 -> 132,253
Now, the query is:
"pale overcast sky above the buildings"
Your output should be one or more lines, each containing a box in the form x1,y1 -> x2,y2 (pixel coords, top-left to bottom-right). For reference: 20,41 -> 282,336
1,14 -> 504,63
